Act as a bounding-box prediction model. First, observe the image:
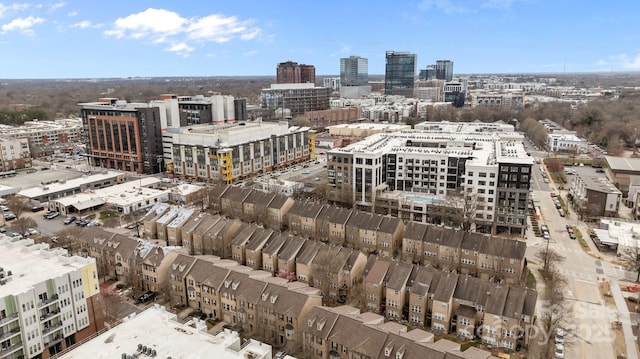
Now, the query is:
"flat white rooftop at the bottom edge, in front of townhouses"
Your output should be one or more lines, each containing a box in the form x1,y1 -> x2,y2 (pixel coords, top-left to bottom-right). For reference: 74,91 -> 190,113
59,304 -> 278,359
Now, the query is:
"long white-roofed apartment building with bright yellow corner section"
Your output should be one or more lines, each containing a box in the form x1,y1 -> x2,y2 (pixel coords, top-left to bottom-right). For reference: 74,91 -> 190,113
165,121 -> 315,183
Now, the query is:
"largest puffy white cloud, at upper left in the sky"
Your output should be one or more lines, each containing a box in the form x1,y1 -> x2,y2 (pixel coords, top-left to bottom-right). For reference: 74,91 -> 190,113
104,8 -> 261,52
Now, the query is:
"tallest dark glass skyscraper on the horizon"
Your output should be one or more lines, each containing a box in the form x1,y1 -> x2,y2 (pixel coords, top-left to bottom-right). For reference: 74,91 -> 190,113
384,51 -> 417,95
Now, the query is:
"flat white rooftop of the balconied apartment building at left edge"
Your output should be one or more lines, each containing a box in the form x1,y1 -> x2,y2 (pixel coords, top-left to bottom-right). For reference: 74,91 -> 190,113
0,239 -> 95,298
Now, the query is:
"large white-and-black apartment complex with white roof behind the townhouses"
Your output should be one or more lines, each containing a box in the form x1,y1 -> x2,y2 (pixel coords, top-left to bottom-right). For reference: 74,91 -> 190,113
327,123 -> 533,234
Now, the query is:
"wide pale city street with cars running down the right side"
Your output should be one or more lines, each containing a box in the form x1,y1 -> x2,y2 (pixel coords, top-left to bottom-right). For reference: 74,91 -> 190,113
527,150 -> 637,358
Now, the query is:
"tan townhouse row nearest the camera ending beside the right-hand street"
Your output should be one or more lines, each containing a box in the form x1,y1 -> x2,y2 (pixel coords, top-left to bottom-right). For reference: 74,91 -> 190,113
364,259 -> 537,350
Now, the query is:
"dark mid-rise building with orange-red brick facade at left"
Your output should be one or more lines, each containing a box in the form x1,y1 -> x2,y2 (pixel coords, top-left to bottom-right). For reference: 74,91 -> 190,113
81,98 -> 166,173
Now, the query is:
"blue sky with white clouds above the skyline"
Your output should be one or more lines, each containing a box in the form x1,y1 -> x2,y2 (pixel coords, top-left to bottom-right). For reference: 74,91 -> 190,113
0,0 -> 640,79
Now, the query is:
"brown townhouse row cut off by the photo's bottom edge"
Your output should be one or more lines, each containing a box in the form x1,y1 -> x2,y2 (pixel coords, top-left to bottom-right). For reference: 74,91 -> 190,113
302,305 -> 497,359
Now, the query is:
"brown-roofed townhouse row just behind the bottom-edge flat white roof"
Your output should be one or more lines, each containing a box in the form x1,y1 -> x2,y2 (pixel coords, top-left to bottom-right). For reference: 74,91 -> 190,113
167,254 -> 322,349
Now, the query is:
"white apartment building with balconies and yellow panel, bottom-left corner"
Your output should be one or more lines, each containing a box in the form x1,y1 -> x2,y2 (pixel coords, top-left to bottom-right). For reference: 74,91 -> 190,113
0,235 -> 104,358
